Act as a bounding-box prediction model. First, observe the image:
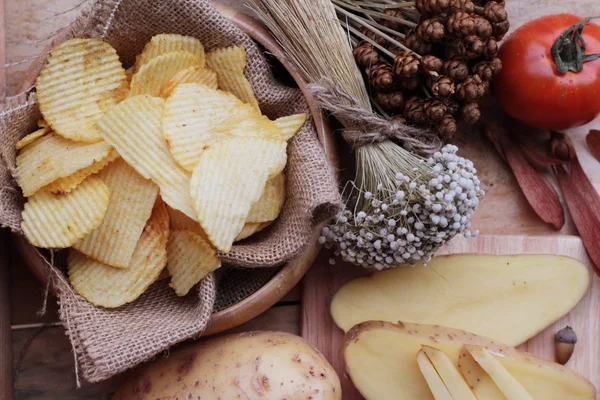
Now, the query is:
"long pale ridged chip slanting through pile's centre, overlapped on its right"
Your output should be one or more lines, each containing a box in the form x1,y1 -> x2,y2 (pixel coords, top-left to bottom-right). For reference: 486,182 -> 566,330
98,95 -> 196,219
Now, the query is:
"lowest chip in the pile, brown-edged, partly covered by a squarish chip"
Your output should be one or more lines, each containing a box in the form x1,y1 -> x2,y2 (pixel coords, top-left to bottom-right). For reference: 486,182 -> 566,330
67,200 -> 169,308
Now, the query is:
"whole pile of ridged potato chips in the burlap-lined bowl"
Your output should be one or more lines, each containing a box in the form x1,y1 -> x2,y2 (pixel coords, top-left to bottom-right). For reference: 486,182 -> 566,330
16,34 -> 306,307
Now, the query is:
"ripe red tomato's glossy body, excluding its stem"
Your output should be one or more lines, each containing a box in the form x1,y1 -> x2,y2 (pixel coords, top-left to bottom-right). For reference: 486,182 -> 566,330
495,14 -> 600,130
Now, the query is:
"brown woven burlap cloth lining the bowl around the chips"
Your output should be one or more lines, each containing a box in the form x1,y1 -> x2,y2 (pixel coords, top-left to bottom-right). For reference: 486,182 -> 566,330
0,0 -> 340,382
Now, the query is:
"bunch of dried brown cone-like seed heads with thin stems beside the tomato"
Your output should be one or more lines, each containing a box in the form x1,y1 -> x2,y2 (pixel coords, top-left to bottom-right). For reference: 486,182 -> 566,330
333,0 -> 510,143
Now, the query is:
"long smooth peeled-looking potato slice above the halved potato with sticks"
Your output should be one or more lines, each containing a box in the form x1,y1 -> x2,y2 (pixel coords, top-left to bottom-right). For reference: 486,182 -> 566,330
331,254 -> 590,346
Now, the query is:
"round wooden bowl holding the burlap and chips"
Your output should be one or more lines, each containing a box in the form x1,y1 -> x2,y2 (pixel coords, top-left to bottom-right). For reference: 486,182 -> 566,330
12,3 -> 337,336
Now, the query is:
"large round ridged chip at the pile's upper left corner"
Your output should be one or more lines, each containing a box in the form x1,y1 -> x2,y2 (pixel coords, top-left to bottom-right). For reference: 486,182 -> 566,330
36,39 -> 129,143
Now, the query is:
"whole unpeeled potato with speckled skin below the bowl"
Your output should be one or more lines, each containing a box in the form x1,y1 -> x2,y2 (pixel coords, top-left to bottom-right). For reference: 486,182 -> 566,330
112,332 -> 342,400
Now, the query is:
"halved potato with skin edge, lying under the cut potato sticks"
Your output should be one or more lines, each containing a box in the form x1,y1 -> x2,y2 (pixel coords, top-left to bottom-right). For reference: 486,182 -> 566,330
343,321 -> 596,400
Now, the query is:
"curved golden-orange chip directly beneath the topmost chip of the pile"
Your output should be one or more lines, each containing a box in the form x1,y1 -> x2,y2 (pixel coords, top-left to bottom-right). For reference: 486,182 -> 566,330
129,51 -> 202,97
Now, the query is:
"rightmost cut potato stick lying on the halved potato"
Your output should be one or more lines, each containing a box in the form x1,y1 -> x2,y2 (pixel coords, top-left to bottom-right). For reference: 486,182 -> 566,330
465,345 -> 533,400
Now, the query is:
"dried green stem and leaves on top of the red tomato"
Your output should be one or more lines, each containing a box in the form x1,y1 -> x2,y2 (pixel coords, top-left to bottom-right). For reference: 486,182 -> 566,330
550,18 -> 600,75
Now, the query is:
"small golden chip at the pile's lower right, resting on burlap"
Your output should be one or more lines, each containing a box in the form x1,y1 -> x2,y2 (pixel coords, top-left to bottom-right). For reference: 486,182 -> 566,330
167,231 -> 221,296
